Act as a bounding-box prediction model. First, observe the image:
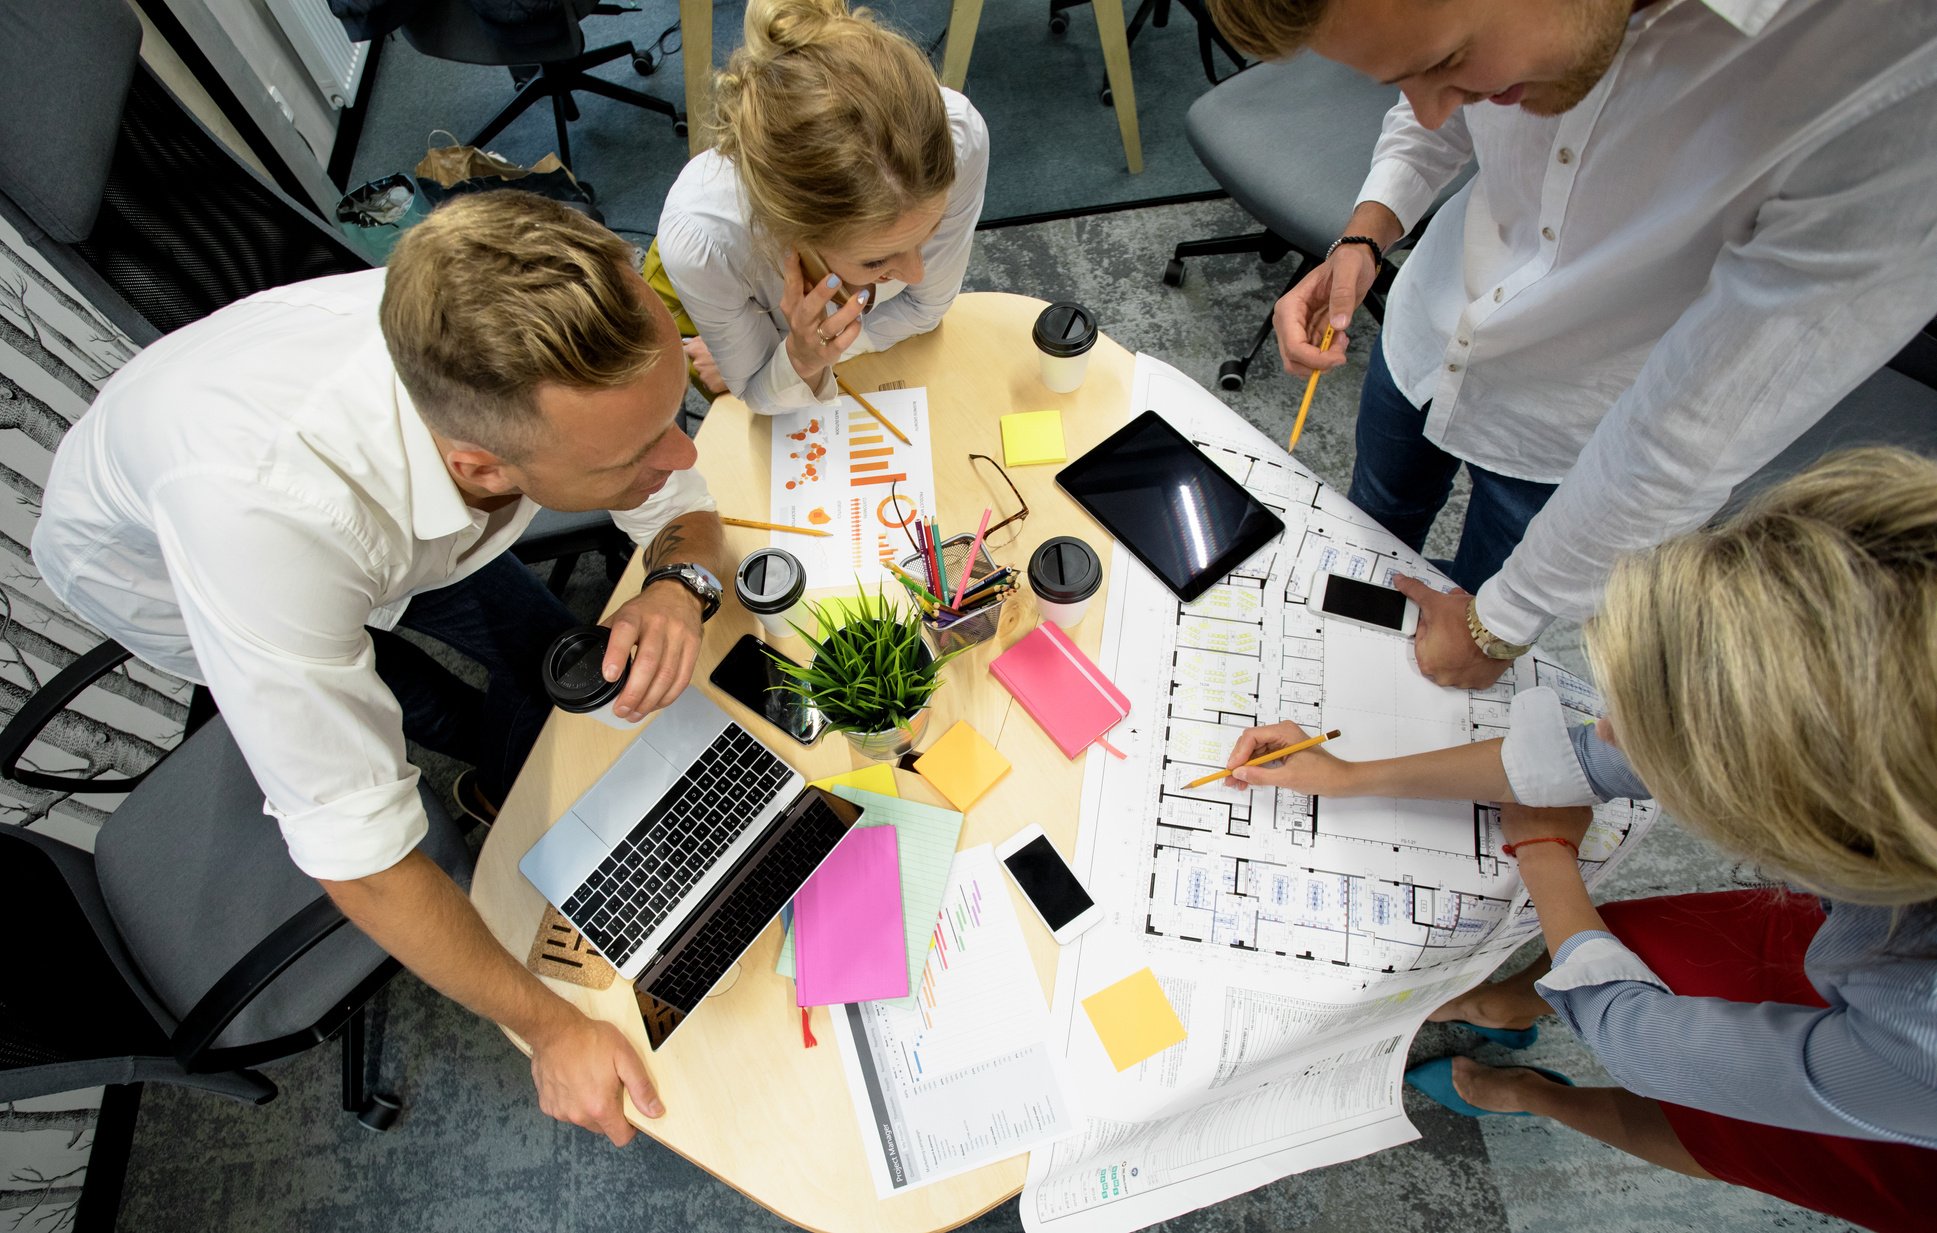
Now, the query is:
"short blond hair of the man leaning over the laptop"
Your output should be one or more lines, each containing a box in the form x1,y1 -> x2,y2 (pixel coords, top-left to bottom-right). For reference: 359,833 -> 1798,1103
382,190 -> 666,461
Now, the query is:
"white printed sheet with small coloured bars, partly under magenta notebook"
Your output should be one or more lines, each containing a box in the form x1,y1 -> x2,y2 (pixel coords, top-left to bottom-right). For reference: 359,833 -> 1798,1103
833,844 -> 1077,1198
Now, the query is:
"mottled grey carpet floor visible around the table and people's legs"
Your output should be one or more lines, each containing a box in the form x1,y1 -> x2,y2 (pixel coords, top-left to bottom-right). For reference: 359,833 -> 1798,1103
118,201 -> 1848,1233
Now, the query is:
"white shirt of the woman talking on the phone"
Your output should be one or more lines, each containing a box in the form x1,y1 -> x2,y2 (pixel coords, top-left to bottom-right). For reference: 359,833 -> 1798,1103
659,85 -> 988,414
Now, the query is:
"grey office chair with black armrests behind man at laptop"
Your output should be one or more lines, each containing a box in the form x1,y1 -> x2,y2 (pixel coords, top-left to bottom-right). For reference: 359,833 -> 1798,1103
0,643 -> 471,1130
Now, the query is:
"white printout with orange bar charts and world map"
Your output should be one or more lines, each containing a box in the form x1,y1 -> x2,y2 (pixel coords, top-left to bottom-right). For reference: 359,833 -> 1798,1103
769,387 -> 936,590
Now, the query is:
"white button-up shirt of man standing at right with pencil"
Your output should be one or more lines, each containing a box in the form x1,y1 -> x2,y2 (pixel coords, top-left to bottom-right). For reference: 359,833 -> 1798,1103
1360,0 -> 1937,643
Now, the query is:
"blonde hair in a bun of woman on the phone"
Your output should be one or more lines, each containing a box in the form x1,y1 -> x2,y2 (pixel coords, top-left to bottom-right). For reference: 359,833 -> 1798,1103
715,0 -> 955,250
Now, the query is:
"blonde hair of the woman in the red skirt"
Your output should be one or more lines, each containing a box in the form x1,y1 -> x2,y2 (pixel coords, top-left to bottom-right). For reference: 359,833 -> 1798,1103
1588,449 -> 1937,904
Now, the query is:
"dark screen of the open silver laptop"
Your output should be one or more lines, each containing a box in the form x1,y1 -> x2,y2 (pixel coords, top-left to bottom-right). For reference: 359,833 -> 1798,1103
647,792 -> 848,1012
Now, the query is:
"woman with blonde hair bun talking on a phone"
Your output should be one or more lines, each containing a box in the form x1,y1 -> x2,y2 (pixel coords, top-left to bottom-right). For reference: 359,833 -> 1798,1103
643,0 -> 988,414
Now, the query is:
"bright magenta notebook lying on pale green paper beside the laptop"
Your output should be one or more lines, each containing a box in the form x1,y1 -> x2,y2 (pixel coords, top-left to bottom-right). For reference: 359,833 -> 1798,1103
794,827 -> 908,1007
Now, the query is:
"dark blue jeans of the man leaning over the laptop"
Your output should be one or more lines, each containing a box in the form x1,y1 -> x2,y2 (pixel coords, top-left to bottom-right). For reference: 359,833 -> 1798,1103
370,552 -> 579,801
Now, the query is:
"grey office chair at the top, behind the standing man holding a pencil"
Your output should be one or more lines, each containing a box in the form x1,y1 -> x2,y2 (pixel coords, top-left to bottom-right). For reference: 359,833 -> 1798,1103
1164,54 -> 1470,389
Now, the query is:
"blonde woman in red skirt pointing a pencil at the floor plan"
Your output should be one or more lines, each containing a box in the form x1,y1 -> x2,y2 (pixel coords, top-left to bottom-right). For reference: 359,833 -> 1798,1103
1226,449 -> 1937,1233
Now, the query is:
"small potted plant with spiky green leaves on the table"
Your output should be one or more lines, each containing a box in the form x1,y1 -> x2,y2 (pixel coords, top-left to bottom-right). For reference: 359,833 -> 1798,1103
775,588 -> 955,761
